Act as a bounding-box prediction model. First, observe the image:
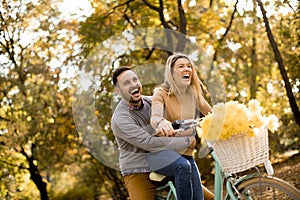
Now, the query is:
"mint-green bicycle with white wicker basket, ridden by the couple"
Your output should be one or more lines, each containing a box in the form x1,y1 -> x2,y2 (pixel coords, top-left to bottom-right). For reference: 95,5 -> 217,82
152,120 -> 300,200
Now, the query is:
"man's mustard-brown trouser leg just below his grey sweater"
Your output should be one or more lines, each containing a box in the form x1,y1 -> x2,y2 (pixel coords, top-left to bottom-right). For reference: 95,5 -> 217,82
124,173 -> 156,200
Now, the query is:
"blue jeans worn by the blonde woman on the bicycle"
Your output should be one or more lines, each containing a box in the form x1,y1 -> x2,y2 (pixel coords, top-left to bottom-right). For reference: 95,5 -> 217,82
147,150 -> 204,200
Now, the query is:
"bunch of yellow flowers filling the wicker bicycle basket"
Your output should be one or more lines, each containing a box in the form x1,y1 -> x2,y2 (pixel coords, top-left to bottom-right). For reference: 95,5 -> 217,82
201,99 -> 279,141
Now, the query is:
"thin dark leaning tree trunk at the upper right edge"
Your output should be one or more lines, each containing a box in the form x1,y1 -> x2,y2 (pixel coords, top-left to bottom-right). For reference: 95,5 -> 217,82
256,0 -> 300,126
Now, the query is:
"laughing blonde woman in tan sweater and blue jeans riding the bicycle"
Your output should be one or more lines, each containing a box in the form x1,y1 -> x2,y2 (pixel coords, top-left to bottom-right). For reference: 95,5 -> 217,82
148,53 -> 212,200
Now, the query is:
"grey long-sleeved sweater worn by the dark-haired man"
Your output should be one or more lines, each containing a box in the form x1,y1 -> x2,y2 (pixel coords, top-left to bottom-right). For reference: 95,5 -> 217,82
111,97 -> 190,176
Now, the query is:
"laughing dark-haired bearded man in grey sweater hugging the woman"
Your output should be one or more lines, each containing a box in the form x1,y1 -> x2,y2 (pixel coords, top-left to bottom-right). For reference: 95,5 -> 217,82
111,67 -> 195,200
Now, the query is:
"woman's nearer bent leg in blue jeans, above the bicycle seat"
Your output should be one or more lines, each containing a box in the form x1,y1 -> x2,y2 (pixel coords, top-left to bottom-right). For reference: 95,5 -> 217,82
147,150 -> 193,200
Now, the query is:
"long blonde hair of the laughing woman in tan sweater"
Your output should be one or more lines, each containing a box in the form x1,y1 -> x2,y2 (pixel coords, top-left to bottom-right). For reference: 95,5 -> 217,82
158,52 -> 203,104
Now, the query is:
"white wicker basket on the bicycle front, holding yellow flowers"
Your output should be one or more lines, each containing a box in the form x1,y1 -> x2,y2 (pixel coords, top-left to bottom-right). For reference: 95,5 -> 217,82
214,126 -> 272,174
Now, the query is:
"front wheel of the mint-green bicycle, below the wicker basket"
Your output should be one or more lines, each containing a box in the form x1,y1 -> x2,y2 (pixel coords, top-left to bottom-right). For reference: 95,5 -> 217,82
237,177 -> 300,200
